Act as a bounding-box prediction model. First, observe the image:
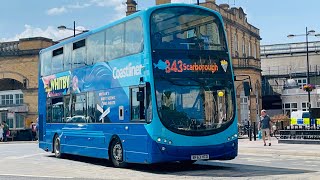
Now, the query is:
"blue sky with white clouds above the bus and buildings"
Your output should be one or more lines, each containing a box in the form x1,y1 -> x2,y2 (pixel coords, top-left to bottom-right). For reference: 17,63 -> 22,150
0,0 -> 320,45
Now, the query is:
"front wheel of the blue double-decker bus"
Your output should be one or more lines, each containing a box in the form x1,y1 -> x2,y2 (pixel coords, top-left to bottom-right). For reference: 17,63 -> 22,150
110,139 -> 127,168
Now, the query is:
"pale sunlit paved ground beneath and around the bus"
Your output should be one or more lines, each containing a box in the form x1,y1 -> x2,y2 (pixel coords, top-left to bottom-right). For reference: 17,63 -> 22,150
0,138 -> 320,180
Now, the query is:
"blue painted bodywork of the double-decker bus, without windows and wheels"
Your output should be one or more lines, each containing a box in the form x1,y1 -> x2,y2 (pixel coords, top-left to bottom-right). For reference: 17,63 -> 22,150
38,4 -> 238,164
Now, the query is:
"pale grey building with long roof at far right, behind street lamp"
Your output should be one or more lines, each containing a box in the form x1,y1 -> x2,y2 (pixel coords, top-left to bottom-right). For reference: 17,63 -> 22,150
261,41 -> 320,116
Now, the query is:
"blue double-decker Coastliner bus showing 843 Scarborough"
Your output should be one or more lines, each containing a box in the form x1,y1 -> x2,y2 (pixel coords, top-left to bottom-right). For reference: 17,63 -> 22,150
38,4 -> 238,167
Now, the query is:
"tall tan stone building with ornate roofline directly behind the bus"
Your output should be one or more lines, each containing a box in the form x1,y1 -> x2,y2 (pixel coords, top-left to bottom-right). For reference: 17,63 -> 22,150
127,0 -> 262,124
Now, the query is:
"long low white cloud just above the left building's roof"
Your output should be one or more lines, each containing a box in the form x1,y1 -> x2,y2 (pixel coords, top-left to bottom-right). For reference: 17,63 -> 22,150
1,24 -> 85,42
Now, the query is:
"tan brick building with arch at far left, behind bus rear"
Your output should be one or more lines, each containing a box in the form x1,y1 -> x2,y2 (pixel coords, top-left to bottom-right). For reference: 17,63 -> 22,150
0,37 -> 53,132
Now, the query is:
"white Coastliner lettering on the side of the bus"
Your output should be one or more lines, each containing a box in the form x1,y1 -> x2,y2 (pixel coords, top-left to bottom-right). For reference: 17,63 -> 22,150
112,63 -> 144,79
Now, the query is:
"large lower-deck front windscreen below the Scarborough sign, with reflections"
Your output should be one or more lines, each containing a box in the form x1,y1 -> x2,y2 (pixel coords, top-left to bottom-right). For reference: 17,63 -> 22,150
156,78 -> 233,135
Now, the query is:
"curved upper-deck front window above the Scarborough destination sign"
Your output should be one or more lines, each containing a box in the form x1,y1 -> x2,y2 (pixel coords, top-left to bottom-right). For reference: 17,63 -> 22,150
151,7 -> 227,50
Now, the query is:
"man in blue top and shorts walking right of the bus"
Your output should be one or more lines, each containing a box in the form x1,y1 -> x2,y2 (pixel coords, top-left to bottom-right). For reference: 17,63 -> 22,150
258,109 -> 272,146
